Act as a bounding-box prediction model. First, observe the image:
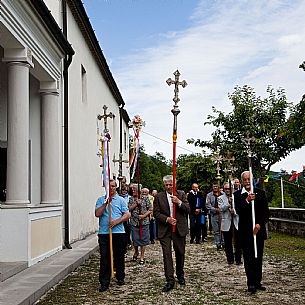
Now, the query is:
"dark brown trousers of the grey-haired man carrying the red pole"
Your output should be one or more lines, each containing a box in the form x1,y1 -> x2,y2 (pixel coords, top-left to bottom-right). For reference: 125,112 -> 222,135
160,232 -> 186,284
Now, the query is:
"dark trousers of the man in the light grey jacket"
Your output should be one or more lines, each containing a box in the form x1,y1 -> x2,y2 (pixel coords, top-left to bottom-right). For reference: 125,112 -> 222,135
222,224 -> 241,263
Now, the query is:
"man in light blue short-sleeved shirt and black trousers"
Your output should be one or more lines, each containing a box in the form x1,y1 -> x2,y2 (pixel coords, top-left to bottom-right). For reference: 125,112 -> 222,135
95,180 -> 130,292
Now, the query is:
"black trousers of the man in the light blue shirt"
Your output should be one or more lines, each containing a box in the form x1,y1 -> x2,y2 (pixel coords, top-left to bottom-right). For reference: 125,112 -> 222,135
98,233 -> 126,287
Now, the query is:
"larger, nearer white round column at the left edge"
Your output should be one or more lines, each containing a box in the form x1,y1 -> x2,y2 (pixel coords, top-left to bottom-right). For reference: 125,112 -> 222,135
6,61 -> 31,204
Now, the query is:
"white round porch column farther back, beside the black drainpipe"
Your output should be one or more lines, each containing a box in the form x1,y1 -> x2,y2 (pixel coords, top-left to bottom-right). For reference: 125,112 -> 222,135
40,85 -> 59,204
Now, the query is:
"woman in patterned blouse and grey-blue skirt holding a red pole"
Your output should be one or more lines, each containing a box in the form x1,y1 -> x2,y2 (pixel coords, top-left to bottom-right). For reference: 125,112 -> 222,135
128,184 -> 153,265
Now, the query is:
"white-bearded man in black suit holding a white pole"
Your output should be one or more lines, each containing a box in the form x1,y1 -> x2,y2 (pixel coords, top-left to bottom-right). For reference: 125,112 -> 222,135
234,171 -> 269,294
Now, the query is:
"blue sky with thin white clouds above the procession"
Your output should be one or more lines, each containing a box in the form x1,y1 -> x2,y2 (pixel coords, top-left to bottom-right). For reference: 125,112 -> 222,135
84,0 -> 305,172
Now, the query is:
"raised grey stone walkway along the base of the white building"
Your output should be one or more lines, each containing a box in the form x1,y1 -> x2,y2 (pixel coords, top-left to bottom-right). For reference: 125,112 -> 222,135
0,234 -> 98,305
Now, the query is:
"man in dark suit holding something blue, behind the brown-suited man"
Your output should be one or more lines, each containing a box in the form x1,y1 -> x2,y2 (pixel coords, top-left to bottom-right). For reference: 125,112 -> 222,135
187,183 -> 206,244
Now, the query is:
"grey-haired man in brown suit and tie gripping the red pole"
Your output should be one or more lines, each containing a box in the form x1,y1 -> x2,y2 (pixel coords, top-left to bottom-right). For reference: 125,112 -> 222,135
153,176 -> 190,292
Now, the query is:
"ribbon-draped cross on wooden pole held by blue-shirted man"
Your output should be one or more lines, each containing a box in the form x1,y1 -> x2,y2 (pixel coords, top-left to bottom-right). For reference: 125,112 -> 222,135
97,105 -> 114,278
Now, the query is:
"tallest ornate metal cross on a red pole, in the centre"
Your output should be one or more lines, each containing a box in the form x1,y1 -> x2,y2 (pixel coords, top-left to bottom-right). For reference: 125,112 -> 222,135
166,70 -> 187,233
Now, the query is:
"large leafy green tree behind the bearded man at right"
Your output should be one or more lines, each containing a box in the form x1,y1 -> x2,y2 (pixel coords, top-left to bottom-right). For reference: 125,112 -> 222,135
188,85 -> 305,177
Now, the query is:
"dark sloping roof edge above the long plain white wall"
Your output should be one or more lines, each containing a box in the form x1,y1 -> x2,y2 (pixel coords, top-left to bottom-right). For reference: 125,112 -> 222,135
66,0 -> 125,106
